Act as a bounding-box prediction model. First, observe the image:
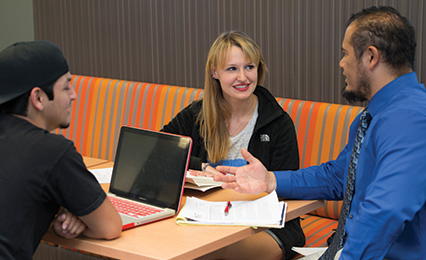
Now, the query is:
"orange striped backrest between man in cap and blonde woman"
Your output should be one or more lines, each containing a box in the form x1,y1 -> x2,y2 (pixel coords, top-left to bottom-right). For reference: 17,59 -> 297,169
56,75 -> 203,161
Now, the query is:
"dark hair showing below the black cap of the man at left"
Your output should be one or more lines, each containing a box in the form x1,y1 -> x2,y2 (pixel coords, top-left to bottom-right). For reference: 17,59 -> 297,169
0,79 -> 57,116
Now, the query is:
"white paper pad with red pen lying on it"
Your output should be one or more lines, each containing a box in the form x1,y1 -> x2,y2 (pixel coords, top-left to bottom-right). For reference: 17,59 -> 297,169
176,191 -> 287,228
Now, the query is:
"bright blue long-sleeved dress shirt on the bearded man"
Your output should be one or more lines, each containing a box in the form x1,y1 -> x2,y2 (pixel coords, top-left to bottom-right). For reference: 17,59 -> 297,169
275,72 -> 426,260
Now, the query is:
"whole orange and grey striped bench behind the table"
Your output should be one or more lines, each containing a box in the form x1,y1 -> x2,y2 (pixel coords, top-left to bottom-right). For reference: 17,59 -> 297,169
37,75 -> 362,259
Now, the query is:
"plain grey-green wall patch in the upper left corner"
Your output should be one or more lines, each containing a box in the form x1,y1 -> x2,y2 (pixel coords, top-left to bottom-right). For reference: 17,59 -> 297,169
0,0 -> 34,50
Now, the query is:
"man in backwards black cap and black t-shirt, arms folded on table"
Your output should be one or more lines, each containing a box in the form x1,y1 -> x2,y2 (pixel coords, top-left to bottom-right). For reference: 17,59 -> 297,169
0,41 -> 122,259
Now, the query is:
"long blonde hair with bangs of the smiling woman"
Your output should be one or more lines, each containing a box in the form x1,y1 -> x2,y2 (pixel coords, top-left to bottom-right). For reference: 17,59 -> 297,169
198,31 -> 267,163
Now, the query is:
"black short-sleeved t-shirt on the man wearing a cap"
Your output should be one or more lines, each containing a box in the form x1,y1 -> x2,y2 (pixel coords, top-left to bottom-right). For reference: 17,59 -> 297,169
0,114 -> 106,259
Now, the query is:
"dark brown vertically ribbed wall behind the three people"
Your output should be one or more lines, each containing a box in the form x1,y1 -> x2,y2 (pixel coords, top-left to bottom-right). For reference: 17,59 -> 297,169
34,0 -> 426,104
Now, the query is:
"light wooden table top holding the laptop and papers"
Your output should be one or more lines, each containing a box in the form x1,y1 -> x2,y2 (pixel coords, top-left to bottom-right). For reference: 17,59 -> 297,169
43,163 -> 323,260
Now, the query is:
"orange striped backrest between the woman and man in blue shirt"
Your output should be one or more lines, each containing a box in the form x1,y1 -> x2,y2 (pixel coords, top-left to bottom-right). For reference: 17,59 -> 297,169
277,98 -> 363,168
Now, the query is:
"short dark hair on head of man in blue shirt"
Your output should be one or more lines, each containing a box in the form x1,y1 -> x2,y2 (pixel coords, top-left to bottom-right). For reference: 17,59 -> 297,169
347,6 -> 416,73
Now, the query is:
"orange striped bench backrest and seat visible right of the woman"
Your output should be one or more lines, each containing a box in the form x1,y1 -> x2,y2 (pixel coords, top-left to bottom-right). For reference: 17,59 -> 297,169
277,98 -> 363,246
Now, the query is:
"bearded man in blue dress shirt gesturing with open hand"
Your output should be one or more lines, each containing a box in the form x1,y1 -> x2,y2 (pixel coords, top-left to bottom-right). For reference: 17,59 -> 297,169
211,7 -> 426,260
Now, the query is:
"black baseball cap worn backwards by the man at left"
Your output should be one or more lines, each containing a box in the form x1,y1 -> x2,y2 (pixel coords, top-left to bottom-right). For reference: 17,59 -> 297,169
0,41 -> 69,105
